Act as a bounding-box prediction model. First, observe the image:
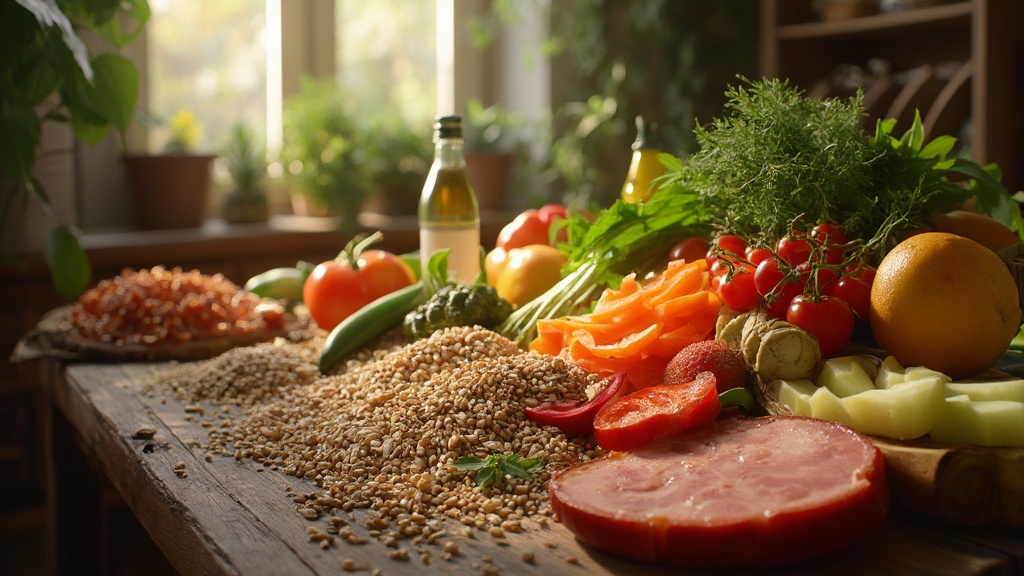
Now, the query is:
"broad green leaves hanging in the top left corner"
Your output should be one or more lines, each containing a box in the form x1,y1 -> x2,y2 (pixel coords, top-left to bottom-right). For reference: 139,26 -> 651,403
0,0 -> 150,299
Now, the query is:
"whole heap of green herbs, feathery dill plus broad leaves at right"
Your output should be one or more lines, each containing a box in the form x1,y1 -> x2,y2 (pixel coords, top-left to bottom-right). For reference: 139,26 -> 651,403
663,79 -> 1024,259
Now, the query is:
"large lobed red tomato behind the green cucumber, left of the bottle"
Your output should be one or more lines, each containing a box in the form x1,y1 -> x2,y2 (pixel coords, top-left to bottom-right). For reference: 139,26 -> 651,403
302,250 -> 416,331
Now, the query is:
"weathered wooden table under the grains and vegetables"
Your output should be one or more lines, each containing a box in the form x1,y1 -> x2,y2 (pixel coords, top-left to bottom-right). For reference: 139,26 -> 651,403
42,360 -> 1024,576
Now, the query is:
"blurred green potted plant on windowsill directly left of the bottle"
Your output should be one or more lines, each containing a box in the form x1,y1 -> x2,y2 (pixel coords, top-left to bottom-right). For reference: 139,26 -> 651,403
364,116 -> 433,216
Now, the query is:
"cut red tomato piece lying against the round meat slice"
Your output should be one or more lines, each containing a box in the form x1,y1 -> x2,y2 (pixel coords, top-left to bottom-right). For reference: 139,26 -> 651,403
594,372 -> 720,450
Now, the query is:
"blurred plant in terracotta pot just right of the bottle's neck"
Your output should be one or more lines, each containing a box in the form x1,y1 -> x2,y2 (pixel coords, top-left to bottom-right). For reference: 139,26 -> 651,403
463,98 -> 525,210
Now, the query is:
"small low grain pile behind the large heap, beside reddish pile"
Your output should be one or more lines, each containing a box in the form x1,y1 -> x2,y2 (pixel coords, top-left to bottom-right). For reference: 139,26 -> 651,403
142,338 -> 323,408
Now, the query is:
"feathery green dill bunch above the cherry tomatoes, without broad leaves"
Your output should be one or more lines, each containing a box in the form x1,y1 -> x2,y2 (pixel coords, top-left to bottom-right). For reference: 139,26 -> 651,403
683,80 -> 880,239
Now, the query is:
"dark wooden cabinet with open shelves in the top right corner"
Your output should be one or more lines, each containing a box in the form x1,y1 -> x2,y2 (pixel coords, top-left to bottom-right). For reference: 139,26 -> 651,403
761,0 -> 1024,192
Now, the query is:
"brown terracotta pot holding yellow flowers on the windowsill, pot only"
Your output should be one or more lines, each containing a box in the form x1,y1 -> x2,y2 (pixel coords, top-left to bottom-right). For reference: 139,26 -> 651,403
123,155 -> 216,230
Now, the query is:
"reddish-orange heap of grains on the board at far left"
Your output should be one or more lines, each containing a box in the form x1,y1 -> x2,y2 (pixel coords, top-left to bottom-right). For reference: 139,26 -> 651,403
69,266 -> 285,345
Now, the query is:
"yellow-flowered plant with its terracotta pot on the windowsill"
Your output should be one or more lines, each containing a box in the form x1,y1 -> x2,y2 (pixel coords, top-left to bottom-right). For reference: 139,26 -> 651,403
123,111 -> 216,230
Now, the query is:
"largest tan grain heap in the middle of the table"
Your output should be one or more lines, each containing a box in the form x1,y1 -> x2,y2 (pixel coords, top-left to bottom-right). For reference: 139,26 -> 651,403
211,327 -> 602,540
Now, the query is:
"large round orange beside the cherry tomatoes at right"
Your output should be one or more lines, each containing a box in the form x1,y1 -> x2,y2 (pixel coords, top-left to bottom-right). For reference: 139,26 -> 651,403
870,232 -> 1021,378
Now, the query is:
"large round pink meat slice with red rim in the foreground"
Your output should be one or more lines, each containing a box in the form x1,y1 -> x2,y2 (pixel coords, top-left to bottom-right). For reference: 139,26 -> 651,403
549,416 -> 890,568
